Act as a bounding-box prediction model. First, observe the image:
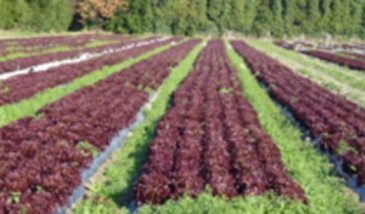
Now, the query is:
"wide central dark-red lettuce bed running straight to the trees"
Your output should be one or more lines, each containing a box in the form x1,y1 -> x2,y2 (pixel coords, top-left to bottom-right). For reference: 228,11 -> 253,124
135,40 -> 306,205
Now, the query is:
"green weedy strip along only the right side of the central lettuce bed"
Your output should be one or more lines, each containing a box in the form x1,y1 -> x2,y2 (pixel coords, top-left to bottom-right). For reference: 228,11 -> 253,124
227,41 -> 361,214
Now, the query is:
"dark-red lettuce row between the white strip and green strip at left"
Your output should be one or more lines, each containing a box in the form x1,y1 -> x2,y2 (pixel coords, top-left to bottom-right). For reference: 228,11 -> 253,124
0,38 -> 180,106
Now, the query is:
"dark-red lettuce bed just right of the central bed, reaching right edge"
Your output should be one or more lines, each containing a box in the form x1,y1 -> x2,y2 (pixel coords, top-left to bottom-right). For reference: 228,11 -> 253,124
231,41 -> 365,184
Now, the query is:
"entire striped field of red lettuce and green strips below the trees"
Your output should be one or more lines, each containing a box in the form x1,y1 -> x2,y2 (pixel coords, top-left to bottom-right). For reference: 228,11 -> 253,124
0,34 -> 365,214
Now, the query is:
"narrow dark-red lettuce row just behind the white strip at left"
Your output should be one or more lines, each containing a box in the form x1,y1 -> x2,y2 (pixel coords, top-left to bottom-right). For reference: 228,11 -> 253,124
0,37 -> 158,74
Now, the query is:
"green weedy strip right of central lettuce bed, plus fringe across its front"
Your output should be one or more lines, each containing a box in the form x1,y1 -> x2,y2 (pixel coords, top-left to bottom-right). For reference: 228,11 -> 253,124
131,41 -> 361,214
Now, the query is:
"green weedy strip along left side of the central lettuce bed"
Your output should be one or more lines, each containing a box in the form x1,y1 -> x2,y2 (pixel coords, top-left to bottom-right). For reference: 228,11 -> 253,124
73,40 -> 203,214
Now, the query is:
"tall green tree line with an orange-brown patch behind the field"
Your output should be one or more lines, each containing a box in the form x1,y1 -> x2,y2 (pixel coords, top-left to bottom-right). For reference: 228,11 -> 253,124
0,0 -> 365,37
